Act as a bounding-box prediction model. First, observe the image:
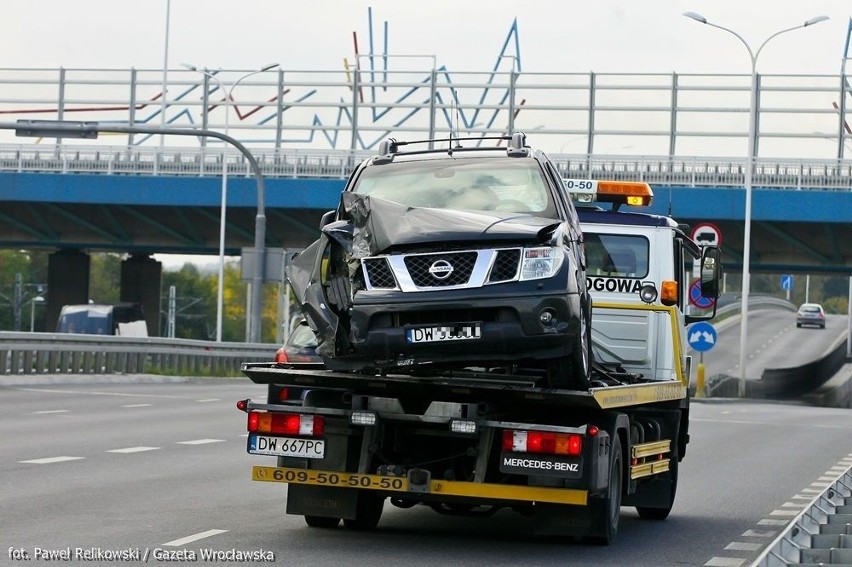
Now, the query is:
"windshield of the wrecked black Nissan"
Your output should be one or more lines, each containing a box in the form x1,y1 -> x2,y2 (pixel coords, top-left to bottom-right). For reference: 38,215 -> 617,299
353,158 -> 558,218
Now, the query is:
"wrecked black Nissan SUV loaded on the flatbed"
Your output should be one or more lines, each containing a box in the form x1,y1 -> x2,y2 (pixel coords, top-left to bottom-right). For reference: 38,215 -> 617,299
287,133 -> 591,388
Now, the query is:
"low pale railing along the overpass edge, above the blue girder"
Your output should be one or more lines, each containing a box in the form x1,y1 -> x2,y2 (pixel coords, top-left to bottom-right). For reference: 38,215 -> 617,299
0,144 -> 852,191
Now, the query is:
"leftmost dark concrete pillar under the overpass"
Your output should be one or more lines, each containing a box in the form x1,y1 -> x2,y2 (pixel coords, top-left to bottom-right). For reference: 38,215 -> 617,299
45,248 -> 90,333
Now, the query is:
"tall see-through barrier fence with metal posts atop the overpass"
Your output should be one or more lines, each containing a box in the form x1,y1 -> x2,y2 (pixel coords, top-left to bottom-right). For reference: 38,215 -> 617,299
0,67 -> 850,159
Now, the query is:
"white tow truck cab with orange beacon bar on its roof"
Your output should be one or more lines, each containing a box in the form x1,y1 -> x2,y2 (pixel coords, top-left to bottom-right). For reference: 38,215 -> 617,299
564,179 -> 719,384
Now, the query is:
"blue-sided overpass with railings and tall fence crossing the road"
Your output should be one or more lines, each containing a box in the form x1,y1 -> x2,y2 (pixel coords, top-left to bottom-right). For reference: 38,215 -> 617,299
0,67 -> 852,338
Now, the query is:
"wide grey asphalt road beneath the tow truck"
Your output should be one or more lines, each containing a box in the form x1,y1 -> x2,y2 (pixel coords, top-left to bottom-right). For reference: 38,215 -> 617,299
0,379 -> 852,566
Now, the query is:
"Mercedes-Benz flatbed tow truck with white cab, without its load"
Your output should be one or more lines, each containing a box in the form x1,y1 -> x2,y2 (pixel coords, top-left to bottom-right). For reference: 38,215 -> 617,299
237,172 -> 721,544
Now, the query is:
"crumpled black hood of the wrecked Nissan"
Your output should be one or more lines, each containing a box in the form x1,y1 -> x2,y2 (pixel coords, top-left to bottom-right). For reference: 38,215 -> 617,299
342,192 -> 560,257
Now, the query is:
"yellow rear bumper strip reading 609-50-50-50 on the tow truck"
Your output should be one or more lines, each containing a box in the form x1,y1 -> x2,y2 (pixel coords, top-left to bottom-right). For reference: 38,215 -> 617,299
251,465 -> 588,506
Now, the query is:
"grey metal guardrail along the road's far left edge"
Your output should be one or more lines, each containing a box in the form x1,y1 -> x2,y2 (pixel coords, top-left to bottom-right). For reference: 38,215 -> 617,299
0,332 -> 278,383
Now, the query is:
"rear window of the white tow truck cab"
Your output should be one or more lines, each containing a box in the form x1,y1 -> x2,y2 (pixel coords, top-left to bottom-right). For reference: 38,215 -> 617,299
583,232 -> 648,278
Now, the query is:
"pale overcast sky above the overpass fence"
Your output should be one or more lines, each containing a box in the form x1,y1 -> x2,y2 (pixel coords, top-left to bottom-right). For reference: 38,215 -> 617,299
5,0 -> 852,74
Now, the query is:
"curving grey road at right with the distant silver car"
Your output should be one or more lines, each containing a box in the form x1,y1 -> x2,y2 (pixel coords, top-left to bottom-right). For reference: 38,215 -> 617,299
693,309 -> 847,380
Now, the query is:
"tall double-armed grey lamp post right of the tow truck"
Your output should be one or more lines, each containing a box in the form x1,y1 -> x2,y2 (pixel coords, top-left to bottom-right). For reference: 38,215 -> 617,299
683,12 -> 828,397
